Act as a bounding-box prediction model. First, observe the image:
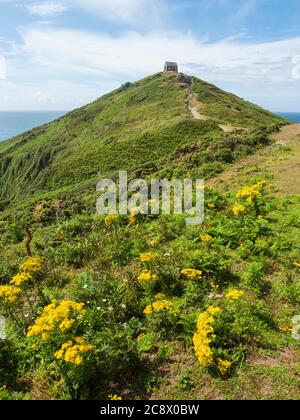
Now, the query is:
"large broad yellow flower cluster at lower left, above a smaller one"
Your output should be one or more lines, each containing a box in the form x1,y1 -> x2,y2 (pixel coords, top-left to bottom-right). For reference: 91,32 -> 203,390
27,300 -> 85,341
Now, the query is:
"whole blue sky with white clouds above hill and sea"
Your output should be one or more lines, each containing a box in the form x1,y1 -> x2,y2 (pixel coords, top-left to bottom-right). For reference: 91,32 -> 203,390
0,0 -> 300,112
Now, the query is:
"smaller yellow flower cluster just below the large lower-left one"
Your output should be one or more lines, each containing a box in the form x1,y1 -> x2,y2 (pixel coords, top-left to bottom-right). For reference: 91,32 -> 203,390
54,337 -> 93,366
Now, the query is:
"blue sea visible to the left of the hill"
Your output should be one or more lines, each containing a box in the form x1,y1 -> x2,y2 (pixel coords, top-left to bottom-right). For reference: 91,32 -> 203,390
0,111 -> 67,141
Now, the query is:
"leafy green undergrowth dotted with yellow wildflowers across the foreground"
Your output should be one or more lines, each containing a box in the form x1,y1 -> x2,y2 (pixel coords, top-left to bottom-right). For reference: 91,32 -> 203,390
0,167 -> 300,399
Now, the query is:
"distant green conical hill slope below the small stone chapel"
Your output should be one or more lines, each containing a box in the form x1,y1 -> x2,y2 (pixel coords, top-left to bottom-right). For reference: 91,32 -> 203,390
0,74 -> 286,210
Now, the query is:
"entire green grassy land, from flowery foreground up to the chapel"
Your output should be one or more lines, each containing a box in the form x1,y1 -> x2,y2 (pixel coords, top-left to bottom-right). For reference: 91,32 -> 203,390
0,74 -> 300,400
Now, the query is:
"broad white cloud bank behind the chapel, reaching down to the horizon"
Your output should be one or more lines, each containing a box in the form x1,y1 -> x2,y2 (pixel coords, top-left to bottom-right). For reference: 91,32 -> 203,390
1,25 -> 300,111
